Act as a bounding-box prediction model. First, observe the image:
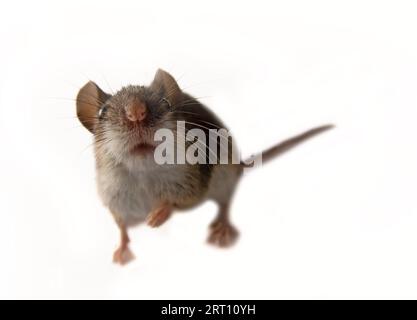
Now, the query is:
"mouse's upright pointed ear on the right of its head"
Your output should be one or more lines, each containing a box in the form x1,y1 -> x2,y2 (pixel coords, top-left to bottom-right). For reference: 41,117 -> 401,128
150,69 -> 182,105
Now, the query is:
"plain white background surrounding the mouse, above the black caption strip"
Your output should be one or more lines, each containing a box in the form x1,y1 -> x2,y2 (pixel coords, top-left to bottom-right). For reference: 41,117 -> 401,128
0,0 -> 417,299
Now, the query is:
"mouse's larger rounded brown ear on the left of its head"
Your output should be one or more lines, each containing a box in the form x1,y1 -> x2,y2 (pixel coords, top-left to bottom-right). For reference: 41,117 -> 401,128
77,81 -> 110,133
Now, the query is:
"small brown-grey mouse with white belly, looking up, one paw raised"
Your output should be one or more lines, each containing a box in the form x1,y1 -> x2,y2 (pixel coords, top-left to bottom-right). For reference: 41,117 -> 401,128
76,69 -> 333,265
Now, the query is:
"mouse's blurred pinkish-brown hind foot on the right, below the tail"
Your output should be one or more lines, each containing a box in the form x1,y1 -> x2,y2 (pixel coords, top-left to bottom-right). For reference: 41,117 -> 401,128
207,205 -> 239,248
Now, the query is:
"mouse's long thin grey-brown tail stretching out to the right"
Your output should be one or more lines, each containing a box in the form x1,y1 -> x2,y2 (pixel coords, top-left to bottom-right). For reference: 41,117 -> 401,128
241,124 -> 334,168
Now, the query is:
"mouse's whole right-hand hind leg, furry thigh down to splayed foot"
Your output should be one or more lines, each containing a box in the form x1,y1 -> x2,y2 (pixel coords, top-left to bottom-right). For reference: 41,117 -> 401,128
207,165 -> 241,248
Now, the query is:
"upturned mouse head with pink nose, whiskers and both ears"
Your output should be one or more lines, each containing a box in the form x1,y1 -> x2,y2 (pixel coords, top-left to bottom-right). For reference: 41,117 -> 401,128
77,69 -> 183,162
